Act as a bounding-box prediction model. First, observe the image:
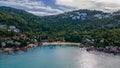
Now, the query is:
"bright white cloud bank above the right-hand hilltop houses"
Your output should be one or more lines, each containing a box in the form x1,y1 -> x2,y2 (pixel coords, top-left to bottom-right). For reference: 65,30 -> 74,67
55,0 -> 120,11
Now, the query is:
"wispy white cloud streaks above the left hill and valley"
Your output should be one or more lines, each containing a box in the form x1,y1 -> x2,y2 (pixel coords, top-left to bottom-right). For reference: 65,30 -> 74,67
0,0 -> 63,16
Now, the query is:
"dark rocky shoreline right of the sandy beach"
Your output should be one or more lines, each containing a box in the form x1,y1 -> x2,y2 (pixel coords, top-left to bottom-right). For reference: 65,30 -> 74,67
79,44 -> 120,55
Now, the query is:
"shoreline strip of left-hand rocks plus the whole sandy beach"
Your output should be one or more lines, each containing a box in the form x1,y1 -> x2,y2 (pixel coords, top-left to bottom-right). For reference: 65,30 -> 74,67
0,42 -> 81,54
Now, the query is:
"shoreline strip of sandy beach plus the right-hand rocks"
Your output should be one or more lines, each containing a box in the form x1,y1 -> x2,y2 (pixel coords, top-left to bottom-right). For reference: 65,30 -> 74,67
42,42 -> 120,55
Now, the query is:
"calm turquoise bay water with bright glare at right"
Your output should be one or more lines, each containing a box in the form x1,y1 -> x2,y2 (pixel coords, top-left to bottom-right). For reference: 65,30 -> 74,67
0,45 -> 120,68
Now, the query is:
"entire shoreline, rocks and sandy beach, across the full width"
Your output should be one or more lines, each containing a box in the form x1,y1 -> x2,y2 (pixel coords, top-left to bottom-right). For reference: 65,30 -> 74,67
0,42 -> 120,55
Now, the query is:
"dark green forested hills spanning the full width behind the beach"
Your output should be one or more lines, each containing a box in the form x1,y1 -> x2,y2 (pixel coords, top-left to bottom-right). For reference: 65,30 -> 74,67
0,6 -> 120,46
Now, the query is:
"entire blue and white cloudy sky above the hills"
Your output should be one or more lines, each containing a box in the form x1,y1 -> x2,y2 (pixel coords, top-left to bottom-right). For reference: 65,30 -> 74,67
0,0 -> 120,16
